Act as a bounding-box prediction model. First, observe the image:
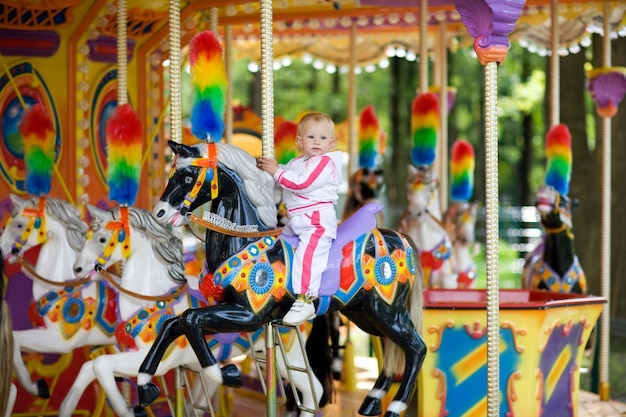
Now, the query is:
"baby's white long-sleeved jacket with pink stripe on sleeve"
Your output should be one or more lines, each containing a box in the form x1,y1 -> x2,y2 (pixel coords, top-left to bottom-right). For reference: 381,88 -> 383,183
274,151 -> 342,217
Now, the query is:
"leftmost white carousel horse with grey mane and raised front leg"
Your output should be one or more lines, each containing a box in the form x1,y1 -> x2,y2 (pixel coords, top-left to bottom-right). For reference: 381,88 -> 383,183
0,195 -> 117,398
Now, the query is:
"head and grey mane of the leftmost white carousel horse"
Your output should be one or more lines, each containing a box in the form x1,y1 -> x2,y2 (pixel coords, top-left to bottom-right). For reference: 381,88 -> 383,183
0,194 -> 87,257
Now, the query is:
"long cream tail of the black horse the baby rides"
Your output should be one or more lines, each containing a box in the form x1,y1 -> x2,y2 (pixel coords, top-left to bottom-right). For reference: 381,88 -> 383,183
384,235 -> 424,375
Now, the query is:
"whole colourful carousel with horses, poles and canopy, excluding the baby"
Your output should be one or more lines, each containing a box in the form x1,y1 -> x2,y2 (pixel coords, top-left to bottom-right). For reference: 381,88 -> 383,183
0,0 -> 626,417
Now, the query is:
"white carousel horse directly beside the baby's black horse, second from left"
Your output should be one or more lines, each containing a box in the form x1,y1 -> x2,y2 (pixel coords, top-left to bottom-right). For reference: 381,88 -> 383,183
59,206 -> 330,417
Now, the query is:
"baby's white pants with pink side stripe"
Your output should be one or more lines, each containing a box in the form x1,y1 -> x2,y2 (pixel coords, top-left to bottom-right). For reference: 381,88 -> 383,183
283,207 -> 337,297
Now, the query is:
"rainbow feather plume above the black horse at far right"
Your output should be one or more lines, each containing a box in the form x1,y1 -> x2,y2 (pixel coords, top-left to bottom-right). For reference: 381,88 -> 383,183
546,123 -> 572,195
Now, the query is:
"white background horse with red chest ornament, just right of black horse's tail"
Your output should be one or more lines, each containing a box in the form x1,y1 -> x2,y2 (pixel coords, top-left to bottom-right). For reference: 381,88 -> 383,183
398,164 -> 457,288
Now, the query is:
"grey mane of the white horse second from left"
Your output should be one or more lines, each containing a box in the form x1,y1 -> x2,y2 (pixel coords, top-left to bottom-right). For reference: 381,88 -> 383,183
91,207 -> 186,282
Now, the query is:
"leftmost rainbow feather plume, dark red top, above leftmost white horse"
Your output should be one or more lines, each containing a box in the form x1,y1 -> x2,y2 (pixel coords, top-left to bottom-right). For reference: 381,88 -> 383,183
20,103 -> 56,196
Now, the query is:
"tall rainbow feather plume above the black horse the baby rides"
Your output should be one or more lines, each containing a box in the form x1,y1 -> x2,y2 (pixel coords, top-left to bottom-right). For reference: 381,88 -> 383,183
189,31 -> 228,142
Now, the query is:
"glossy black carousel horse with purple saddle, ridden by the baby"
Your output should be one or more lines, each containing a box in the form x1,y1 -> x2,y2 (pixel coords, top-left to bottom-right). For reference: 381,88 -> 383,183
139,141 -> 426,417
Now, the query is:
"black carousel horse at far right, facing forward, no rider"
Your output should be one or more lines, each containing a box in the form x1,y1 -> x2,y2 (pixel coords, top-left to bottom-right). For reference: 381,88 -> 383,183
522,185 -> 587,294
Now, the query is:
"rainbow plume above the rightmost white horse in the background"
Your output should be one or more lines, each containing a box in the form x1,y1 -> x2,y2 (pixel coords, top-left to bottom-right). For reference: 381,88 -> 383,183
450,139 -> 475,201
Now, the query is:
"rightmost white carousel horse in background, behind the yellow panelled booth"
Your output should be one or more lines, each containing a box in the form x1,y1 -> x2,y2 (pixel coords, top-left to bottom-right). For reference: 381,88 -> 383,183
444,201 -> 478,289
